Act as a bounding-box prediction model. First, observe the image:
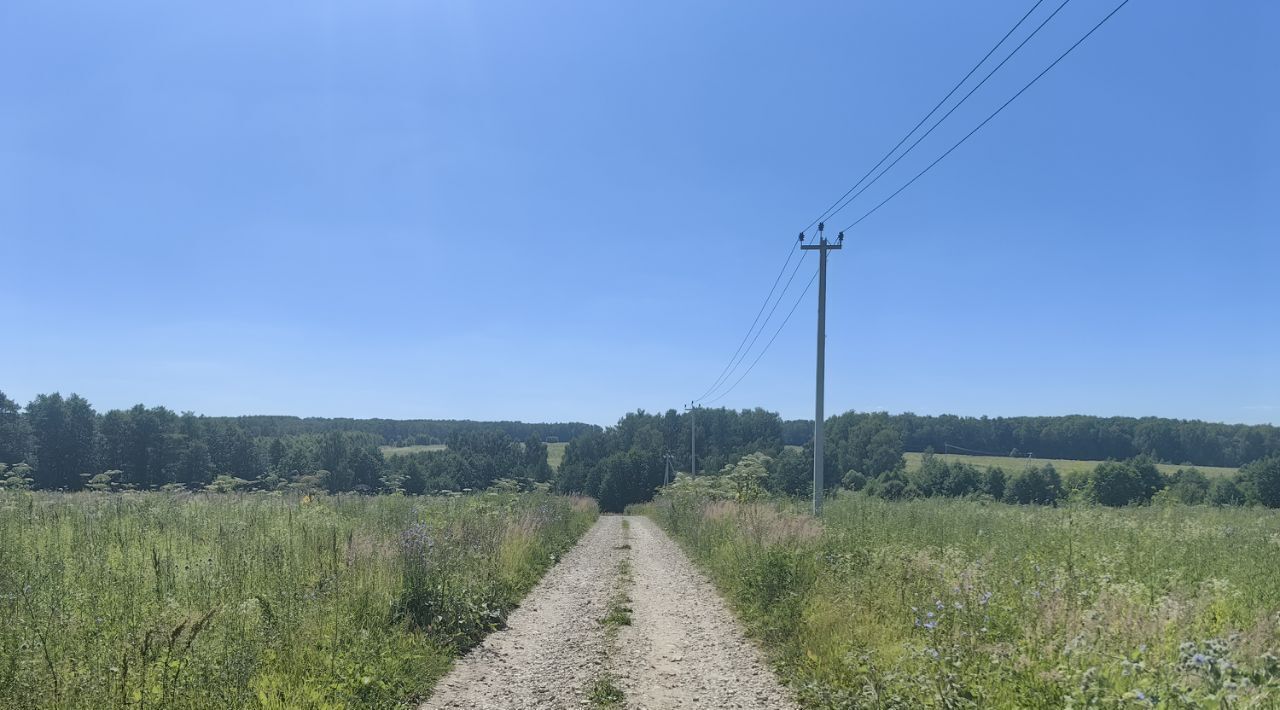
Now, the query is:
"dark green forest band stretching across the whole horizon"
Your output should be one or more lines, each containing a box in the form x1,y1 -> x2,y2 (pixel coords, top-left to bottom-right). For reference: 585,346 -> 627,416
0,393 -> 1280,510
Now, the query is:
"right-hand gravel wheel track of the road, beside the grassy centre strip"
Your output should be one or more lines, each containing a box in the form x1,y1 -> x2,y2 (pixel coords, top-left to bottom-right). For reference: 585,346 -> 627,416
609,516 -> 796,710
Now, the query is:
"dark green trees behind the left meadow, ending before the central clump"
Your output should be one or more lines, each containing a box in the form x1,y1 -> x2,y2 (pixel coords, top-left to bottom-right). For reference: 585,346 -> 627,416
0,393 -> 558,493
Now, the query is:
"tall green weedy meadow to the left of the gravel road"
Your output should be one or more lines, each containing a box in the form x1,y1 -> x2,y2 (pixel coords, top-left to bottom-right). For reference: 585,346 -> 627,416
0,493 -> 596,710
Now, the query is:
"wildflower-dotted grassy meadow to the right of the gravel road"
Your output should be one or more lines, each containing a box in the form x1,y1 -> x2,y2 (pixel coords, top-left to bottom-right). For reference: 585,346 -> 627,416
643,491 -> 1280,709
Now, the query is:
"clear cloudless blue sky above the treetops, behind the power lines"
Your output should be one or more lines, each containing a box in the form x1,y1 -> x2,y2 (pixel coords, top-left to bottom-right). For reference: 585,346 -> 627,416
0,0 -> 1280,423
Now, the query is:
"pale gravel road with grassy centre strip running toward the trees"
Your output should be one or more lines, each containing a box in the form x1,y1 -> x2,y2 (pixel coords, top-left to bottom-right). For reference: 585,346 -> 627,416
422,516 -> 795,710
